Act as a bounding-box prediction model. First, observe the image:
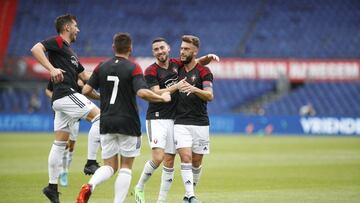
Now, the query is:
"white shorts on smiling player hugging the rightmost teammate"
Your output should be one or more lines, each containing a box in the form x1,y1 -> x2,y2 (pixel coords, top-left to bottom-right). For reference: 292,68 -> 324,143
146,119 -> 176,154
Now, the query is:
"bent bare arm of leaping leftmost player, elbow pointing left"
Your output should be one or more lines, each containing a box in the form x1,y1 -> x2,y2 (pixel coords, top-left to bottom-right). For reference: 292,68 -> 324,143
31,42 -> 65,83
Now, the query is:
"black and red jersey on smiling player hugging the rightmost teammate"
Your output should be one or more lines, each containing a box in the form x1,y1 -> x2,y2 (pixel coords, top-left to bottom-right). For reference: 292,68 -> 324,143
145,59 -> 183,120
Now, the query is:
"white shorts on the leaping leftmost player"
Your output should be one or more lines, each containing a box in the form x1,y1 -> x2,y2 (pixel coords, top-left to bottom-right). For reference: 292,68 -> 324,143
52,93 -> 96,132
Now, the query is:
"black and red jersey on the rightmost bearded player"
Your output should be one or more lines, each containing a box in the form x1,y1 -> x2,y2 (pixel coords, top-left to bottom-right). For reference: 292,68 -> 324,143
175,64 -> 213,126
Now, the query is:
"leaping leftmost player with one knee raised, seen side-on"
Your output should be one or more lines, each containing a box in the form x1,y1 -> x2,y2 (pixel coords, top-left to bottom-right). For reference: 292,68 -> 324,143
31,14 -> 100,203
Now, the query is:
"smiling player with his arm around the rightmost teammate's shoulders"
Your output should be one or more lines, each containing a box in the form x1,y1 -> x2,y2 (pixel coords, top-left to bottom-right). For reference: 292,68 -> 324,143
134,38 -> 219,203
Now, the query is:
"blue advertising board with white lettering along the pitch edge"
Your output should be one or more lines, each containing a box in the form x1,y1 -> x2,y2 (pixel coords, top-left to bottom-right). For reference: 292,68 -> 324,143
0,114 -> 360,136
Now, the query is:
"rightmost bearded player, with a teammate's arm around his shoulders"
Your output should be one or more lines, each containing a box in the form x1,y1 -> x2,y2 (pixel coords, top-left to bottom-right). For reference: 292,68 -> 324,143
174,35 -> 214,203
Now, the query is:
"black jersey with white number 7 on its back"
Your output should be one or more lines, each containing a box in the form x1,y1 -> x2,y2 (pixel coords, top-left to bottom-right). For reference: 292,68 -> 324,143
87,57 -> 147,136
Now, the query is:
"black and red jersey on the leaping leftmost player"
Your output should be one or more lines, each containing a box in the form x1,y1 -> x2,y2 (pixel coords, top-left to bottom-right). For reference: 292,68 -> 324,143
41,36 -> 84,101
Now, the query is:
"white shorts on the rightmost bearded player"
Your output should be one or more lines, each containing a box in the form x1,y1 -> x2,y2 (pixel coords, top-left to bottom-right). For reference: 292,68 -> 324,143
174,124 -> 210,154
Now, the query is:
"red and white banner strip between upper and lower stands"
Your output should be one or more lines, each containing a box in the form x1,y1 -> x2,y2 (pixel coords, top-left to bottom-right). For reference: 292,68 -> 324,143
23,57 -> 360,82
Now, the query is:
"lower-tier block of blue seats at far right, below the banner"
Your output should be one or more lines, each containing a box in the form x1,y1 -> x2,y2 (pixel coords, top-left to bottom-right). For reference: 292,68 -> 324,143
264,82 -> 360,116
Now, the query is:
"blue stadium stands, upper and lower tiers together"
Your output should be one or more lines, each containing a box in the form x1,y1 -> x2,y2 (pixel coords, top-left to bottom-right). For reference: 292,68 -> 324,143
0,0 -> 360,116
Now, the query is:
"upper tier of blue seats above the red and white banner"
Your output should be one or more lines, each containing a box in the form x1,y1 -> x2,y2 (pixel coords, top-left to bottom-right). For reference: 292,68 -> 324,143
8,0 -> 360,58
